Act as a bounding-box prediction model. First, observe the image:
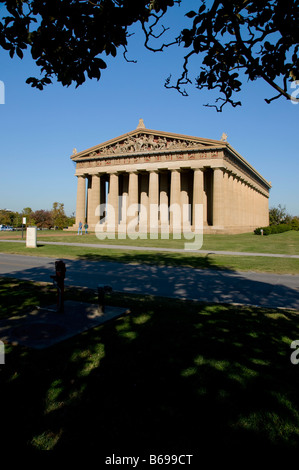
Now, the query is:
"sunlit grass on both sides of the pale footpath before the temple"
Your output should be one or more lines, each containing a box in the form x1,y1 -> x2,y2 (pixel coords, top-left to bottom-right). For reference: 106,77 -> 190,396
0,231 -> 299,274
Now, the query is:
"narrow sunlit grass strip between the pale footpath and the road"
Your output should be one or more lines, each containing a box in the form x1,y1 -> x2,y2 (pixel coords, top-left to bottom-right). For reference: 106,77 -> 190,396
0,242 -> 299,274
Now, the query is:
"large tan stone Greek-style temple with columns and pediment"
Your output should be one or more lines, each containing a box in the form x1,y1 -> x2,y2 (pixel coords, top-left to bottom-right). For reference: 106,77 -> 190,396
71,119 -> 271,233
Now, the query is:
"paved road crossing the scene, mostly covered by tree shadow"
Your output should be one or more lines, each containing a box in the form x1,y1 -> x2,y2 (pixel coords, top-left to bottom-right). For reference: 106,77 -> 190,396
0,253 -> 299,310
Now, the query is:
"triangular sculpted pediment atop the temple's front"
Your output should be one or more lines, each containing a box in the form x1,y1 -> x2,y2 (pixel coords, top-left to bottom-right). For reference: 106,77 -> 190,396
71,128 -> 225,161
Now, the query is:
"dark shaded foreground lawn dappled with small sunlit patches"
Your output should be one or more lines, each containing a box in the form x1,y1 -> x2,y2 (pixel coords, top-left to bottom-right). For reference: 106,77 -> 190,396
0,279 -> 299,454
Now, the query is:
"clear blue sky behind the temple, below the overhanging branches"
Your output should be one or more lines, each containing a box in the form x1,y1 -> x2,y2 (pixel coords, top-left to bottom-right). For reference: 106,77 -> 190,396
0,0 -> 299,215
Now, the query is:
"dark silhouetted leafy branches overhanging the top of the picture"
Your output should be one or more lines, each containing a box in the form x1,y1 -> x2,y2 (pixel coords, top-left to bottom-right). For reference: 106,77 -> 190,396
0,0 -> 299,111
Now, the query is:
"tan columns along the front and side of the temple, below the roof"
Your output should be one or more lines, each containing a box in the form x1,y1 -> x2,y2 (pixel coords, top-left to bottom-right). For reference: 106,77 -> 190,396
76,168 -> 268,231
